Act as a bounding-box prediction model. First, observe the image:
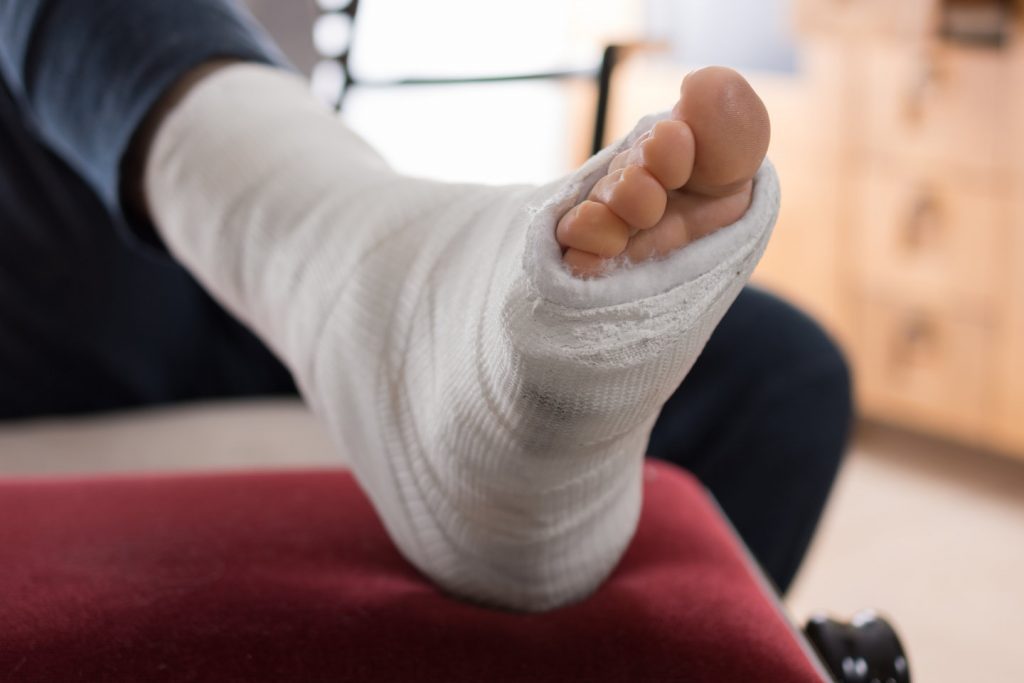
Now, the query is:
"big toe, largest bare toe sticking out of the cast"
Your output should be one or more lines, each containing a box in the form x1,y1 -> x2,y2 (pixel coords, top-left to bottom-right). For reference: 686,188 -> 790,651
673,67 -> 771,197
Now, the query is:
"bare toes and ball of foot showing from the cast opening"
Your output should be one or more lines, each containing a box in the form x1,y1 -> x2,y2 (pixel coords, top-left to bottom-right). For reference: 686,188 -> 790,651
555,67 -> 769,278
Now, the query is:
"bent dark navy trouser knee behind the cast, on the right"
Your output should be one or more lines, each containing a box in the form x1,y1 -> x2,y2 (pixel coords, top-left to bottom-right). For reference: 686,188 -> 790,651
647,288 -> 852,593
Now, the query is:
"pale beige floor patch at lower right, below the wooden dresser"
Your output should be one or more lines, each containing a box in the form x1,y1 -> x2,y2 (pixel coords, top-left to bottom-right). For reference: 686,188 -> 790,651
786,427 -> 1024,683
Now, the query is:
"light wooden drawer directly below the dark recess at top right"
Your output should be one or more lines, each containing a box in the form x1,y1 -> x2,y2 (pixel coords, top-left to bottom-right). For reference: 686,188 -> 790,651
855,42 -> 1016,175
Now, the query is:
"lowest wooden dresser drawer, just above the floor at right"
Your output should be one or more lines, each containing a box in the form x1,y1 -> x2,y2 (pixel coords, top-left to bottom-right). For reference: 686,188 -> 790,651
854,298 -> 994,441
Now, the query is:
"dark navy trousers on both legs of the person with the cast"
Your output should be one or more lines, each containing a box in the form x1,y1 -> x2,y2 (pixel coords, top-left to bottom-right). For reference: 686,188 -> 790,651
0,0 -> 851,591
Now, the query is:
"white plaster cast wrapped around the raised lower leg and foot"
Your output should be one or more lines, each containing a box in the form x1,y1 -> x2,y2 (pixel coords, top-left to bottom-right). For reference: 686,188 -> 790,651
145,65 -> 778,610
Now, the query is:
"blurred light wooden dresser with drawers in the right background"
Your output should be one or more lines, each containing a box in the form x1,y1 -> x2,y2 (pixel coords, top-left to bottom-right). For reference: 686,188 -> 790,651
757,0 -> 1024,458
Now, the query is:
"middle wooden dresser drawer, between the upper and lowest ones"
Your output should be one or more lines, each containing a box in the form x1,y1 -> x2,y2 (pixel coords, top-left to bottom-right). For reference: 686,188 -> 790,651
850,164 -> 1012,315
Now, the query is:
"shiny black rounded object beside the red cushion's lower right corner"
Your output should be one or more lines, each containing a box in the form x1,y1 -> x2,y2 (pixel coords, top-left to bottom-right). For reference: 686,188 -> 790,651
804,609 -> 910,683
